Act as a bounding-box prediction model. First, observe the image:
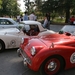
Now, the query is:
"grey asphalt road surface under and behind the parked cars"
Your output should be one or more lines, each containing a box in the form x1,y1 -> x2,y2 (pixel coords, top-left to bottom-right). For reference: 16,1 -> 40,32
0,25 -> 75,75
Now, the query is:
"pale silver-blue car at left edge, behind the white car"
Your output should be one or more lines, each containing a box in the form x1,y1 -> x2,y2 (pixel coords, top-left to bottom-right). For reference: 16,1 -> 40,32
0,17 -> 20,29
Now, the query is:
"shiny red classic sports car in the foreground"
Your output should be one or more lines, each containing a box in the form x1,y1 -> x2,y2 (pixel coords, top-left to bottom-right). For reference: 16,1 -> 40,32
17,33 -> 75,75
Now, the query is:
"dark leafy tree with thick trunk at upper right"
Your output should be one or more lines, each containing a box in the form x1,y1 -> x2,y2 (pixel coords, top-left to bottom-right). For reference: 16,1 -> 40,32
41,0 -> 75,23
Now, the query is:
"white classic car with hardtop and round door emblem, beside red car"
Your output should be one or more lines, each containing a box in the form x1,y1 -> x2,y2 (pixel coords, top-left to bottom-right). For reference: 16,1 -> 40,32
0,21 -> 55,51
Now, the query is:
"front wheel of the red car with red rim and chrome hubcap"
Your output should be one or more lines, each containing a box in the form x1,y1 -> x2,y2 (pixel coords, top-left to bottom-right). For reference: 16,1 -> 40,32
40,56 -> 64,75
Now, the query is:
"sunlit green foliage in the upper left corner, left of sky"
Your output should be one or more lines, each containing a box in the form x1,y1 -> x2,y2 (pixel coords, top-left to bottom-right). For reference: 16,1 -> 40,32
0,0 -> 20,16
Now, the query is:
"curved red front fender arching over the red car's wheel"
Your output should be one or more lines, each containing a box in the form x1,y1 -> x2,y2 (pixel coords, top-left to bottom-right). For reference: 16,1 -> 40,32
32,46 -> 74,71
